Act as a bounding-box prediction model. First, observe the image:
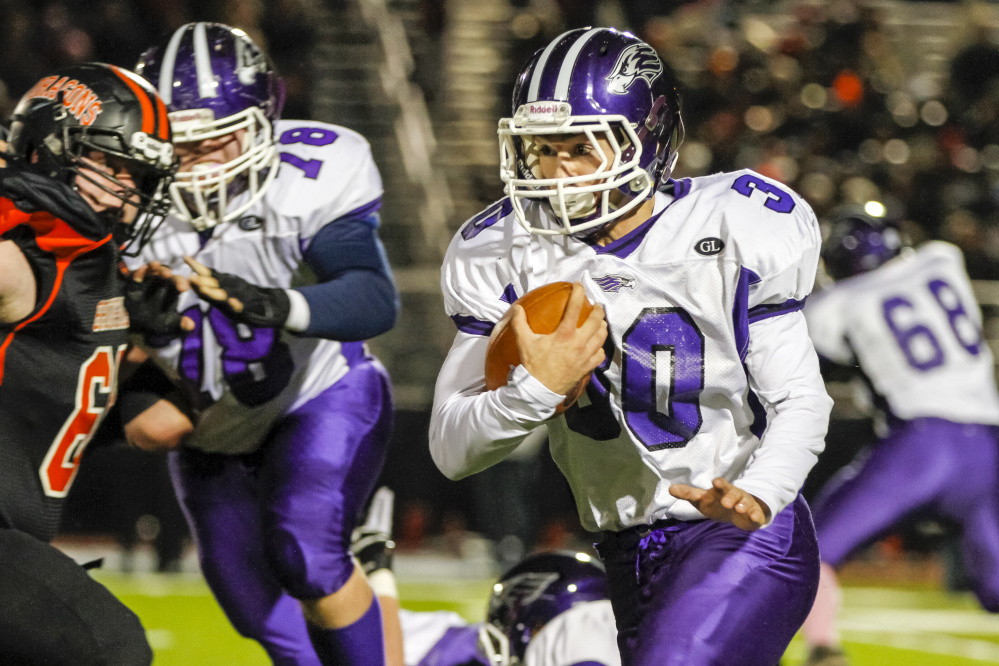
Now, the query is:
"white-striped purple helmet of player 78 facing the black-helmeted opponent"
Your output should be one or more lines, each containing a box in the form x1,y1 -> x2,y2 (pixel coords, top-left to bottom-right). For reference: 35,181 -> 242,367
135,23 -> 284,231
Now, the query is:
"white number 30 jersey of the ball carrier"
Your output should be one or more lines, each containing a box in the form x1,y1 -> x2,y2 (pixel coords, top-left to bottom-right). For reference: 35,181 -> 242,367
431,170 -> 831,531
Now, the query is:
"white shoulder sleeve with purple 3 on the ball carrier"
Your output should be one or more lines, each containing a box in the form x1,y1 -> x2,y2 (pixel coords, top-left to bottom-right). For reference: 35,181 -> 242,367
726,170 -> 822,324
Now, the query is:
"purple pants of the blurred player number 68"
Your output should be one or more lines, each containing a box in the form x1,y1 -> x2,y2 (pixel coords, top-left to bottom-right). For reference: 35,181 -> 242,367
815,418 -> 999,613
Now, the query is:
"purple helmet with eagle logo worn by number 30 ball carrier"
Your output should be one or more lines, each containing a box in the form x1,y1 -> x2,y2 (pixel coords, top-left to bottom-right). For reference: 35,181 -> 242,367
499,28 -> 683,235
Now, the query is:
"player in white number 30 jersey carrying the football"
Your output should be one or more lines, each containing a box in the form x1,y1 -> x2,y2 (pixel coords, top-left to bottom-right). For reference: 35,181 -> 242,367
430,28 -> 831,666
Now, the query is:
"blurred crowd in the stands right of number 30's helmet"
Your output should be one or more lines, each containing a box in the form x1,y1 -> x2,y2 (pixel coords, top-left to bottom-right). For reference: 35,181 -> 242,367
502,0 -> 999,279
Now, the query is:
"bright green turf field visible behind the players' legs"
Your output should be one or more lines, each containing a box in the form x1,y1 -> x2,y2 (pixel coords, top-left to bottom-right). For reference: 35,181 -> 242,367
98,572 -> 999,666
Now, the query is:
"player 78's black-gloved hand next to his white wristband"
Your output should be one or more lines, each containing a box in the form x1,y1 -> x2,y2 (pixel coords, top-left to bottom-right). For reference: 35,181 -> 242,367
184,257 -> 291,328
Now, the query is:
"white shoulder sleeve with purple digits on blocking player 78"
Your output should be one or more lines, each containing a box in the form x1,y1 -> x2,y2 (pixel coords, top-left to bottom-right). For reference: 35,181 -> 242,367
272,120 -> 383,251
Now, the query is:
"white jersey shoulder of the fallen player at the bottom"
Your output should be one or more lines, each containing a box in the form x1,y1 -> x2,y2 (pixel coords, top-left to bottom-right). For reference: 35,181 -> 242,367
524,601 -> 621,666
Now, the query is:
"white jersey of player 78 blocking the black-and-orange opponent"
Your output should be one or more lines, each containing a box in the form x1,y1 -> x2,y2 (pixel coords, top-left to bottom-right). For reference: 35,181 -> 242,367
127,120 -> 382,453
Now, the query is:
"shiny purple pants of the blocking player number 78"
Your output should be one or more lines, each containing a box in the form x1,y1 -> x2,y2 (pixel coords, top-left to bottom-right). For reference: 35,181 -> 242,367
170,361 -> 392,666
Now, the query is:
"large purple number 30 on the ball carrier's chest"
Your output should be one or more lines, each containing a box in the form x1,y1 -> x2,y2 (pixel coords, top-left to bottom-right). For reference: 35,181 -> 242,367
565,307 -> 704,451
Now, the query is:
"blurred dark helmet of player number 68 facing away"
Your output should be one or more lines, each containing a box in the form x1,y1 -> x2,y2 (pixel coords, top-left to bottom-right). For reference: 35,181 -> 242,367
822,207 -> 902,280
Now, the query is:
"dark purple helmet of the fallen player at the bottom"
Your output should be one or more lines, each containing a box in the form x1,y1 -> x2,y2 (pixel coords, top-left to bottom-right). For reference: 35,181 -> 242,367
479,552 -> 607,666
